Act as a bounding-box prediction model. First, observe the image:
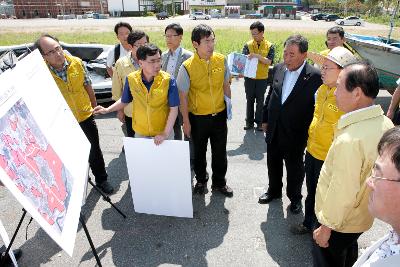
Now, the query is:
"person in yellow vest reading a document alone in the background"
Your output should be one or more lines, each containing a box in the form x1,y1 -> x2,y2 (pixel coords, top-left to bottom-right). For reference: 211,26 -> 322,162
242,21 -> 275,131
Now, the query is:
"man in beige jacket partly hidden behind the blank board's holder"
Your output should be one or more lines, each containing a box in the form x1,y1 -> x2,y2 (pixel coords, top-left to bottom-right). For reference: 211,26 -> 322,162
112,30 -> 149,140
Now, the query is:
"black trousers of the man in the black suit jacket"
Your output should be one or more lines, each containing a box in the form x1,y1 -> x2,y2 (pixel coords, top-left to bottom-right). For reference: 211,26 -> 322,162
267,131 -> 304,203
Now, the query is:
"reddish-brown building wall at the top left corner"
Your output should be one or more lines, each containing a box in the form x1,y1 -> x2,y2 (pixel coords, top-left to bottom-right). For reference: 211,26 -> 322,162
14,0 -> 108,18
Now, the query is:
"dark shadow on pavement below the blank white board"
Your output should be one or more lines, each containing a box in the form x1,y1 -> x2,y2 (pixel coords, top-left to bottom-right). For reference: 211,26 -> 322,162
81,188 -> 229,266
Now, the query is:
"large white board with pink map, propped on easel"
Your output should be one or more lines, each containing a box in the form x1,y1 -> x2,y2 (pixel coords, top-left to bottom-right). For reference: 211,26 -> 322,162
0,51 -> 90,256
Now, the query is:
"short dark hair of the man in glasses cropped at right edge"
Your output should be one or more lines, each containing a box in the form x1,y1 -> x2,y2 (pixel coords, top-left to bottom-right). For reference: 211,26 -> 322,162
378,126 -> 400,172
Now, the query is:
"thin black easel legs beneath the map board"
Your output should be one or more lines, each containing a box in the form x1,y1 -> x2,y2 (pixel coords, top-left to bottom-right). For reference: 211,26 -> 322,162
0,177 -> 126,267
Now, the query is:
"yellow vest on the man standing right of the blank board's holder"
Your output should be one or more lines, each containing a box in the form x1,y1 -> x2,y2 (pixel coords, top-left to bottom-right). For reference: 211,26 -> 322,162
183,53 -> 225,115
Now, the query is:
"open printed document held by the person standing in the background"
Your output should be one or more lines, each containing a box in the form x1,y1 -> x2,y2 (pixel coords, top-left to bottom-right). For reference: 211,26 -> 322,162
228,53 -> 258,78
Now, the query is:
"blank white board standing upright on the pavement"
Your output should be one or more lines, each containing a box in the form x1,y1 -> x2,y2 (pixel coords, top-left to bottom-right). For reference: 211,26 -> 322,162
124,137 -> 193,218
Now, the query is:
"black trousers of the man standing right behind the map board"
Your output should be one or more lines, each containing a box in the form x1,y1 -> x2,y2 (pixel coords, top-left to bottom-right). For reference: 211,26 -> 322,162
79,116 -> 107,183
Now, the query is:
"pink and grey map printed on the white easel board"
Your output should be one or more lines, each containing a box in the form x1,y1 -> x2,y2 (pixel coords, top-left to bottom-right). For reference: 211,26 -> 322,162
0,99 -> 73,232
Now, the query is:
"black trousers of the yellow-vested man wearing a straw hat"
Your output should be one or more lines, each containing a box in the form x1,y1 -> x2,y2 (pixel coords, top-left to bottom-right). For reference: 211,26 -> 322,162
303,152 -> 324,230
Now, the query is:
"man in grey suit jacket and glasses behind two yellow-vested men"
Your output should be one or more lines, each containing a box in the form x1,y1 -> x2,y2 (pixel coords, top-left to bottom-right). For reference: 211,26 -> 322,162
161,23 -> 193,140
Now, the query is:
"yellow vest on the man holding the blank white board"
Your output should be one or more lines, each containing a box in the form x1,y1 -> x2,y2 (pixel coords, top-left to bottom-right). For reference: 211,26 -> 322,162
128,70 -> 171,136
